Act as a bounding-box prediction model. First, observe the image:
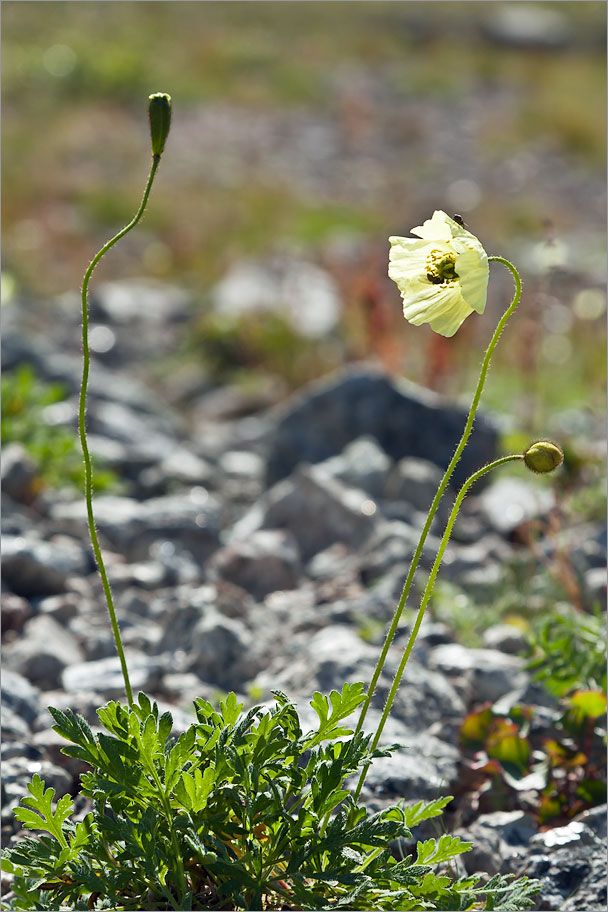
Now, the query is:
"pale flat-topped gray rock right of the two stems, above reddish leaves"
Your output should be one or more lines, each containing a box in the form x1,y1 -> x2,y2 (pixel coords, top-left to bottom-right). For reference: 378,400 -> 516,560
429,643 -> 529,703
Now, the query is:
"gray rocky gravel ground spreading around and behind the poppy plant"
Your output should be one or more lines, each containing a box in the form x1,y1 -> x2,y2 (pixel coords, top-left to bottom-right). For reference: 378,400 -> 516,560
1,285 -> 606,912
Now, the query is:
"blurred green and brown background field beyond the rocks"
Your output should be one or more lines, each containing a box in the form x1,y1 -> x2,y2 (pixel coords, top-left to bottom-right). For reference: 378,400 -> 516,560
2,0 -> 606,441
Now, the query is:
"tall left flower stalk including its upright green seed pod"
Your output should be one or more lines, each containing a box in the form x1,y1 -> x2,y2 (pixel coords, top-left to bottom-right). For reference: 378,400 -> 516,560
78,92 -> 171,706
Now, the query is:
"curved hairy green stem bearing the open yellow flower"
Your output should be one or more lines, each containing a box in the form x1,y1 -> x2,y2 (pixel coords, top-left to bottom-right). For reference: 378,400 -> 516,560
355,256 -> 521,732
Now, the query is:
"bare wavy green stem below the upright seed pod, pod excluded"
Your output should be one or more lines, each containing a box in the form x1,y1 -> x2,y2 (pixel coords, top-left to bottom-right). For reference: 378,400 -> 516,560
78,155 -> 160,706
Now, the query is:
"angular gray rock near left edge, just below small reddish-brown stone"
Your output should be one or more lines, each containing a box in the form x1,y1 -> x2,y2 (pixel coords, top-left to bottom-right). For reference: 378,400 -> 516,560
5,614 -> 84,690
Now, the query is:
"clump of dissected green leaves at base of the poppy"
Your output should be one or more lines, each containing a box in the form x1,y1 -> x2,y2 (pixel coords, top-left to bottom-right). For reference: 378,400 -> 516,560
2,684 -> 538,910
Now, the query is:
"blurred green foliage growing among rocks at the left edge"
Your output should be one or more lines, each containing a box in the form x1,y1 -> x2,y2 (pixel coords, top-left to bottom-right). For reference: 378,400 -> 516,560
2,363 -> 117,495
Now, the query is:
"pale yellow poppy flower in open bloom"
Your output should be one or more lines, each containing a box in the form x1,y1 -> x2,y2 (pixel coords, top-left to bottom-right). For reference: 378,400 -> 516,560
388,209 -> 489,336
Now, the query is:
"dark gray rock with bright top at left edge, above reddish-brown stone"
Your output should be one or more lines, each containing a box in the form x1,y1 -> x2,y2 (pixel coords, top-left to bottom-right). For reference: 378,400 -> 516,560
2,534 -> 91,598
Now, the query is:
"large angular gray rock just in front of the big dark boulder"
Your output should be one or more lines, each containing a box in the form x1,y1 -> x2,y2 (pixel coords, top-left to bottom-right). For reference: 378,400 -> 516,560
231,466 -> 377,561
